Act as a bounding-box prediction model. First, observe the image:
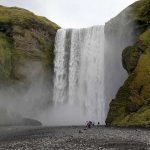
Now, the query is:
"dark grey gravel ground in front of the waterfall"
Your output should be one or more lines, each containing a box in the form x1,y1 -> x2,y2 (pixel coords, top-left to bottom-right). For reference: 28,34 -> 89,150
0,126 -> 150,150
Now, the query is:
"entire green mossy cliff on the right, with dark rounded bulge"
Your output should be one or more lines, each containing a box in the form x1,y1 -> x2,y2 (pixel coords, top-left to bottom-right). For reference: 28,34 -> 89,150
106,0 -> 150,126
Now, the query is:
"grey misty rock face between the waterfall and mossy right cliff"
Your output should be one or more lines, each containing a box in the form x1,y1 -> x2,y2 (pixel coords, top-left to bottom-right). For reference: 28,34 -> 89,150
104,5 -> 136,115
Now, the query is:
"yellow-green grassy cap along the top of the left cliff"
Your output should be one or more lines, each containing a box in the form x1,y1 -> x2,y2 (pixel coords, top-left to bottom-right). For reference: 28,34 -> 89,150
0,5 -> 60,30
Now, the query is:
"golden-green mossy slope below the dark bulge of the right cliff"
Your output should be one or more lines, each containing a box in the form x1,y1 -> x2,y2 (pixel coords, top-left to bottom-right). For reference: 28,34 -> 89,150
106,33 -> 150,125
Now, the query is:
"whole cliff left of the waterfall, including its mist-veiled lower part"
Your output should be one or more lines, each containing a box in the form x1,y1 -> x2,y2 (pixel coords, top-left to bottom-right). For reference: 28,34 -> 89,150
0,6 -> 59,124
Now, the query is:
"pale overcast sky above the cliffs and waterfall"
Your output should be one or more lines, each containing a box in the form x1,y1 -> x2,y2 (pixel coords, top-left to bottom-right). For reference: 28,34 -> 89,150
0,0 -> 137,28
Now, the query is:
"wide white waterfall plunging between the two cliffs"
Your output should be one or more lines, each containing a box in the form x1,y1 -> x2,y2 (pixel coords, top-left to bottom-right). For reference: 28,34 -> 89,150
53,26 -> 105,124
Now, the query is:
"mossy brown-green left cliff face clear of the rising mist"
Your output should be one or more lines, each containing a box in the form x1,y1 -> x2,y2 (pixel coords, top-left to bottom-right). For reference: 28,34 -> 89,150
0,6 -> 59,83
